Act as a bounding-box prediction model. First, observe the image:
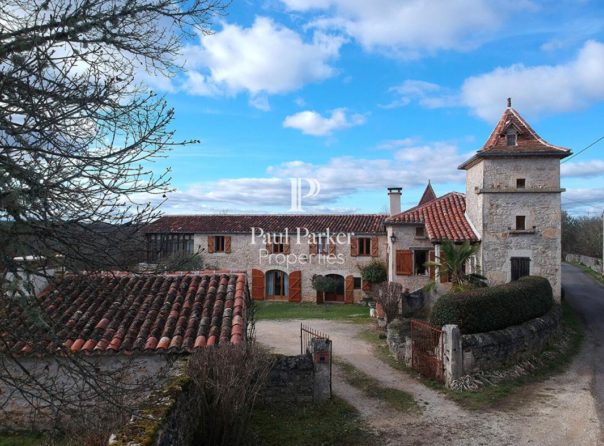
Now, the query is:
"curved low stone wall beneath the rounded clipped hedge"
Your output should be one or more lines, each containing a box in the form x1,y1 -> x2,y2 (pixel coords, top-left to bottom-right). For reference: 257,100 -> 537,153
461,305 -> 561,375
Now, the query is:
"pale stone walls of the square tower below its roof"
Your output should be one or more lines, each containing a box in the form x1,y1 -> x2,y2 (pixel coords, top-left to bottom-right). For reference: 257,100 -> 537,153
466,157 -> 562,300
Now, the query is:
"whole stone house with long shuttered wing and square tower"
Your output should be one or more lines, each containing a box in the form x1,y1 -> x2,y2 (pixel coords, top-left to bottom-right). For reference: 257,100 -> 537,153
145,103 -> 570,303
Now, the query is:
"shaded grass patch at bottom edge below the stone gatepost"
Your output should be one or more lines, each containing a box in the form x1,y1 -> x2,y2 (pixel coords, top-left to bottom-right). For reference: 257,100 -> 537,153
252,397 -> 379,446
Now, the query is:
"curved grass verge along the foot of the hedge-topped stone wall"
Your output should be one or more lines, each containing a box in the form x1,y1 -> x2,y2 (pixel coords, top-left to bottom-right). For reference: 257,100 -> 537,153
360,302 -> 584,410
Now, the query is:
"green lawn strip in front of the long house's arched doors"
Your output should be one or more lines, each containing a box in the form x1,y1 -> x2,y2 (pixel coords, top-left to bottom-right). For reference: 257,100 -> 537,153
256,301 -> 370,322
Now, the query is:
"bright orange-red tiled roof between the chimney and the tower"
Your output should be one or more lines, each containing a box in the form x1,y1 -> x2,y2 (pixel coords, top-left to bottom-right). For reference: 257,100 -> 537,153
386,192 -> 478,241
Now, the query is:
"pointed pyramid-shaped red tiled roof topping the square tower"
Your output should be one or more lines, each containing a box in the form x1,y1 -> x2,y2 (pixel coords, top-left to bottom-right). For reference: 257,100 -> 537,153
459,107 -> 571,169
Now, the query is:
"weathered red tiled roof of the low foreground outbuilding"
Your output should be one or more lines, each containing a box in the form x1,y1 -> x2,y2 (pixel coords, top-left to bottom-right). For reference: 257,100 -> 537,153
0,272 -> 249,354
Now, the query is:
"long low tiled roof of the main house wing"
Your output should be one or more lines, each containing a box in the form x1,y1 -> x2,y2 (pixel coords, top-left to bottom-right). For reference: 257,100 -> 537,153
145,214 -> 386,234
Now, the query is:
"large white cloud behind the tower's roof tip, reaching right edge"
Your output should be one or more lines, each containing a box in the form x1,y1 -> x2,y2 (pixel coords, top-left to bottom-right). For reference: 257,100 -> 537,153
461,41 -> 604,121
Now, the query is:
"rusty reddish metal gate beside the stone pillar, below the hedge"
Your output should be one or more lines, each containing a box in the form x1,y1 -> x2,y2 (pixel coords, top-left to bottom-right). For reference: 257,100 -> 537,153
411,319 -> 444,381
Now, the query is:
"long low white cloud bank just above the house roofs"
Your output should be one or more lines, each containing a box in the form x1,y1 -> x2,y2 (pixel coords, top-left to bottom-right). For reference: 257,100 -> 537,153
138,140 -> 470,214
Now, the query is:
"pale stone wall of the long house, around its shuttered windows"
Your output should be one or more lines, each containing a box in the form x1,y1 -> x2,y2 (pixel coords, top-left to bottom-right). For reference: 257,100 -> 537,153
194,234 -> 388,302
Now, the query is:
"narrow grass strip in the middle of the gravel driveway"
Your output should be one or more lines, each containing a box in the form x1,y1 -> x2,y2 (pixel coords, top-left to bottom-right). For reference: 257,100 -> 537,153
337,361 -> 419,412
